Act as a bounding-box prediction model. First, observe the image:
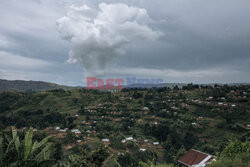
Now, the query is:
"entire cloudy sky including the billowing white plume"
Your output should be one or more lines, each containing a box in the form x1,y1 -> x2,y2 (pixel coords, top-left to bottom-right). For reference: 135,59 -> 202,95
0,0 -> 250,86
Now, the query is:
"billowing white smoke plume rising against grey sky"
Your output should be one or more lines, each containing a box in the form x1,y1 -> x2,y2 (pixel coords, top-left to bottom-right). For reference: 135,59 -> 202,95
57,3 -> 161,74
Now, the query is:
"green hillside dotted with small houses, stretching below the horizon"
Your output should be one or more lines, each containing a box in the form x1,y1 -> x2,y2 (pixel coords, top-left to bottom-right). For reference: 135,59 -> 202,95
0,84 -> 250,167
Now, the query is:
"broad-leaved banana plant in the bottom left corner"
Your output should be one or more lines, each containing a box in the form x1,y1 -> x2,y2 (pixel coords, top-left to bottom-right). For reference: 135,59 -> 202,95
0,127 -> 54,167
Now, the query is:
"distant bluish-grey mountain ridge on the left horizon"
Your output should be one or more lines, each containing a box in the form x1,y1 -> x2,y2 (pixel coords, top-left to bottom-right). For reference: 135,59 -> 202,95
0,79 -> 75,91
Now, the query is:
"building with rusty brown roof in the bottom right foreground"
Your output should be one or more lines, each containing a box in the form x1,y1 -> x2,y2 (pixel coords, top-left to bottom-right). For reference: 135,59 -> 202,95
178,149 -> 215,167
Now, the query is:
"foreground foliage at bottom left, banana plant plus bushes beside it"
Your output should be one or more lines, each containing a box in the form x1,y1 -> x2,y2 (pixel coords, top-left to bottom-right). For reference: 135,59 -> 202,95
0,128 -> 109,167
